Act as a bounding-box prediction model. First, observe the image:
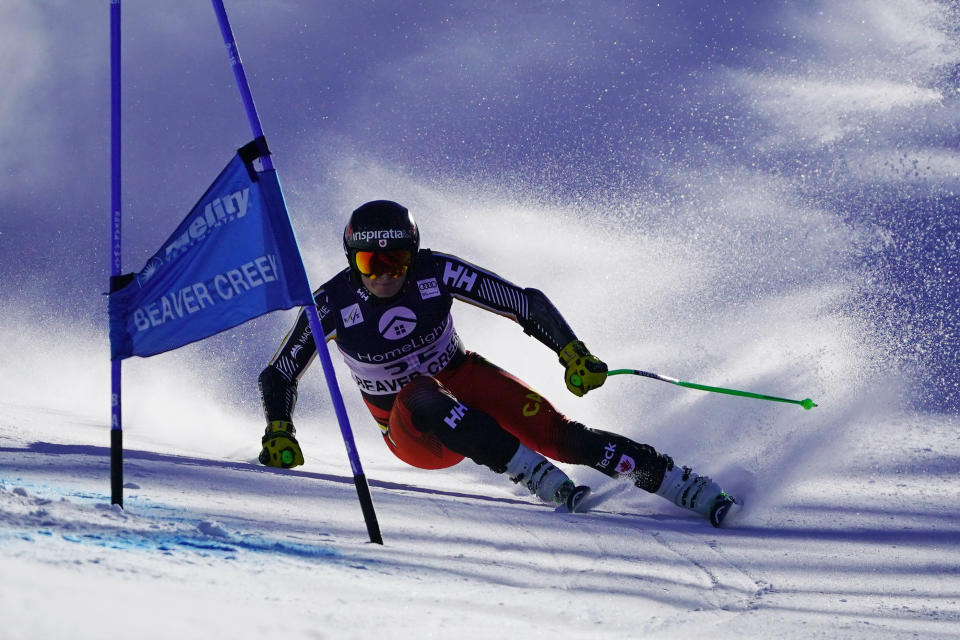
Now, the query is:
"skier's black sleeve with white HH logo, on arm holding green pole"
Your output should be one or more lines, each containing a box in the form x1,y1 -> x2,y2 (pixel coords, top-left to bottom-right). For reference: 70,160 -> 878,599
432,252 -> 577,353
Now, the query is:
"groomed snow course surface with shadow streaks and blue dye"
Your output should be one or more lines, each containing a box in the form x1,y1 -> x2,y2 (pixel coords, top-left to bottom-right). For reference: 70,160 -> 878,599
0,405 -> 960,638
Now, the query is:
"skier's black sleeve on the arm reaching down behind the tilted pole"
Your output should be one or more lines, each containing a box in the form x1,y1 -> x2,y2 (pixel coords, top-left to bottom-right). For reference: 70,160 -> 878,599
258,289 -> 336,422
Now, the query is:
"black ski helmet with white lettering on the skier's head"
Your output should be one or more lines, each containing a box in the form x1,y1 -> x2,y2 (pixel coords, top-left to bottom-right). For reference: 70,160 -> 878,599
343,200 -> 420,278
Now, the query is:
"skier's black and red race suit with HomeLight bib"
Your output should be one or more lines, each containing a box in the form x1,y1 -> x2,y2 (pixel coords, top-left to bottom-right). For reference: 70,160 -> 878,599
259,249 -> 669,492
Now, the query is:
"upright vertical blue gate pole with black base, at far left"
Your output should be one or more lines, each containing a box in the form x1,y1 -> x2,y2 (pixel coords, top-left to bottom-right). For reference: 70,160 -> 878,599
110,0 -> 123,507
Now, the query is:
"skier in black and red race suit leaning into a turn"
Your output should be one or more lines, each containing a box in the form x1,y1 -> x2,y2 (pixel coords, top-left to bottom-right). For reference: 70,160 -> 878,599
259,200 -> 736,527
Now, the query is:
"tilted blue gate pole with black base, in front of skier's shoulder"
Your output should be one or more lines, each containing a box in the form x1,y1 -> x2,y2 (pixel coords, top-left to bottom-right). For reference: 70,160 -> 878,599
211,0 -> 383,544
